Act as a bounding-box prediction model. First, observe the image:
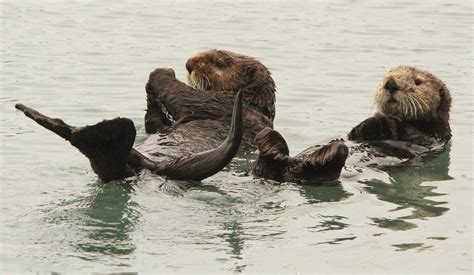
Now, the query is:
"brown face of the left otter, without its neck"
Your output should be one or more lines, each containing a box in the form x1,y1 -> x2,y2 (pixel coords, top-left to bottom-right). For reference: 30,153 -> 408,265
186,50 -> 273,91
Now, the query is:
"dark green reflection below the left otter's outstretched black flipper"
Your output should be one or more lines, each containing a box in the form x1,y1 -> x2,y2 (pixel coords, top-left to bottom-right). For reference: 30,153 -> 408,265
77,184 -> 140,258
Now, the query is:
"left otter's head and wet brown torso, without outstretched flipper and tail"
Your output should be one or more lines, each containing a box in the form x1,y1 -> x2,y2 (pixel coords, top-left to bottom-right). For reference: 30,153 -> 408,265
142,50 -> 276,158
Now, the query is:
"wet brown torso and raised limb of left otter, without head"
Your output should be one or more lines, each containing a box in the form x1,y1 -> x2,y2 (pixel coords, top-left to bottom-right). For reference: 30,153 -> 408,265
139,69 -> 273,160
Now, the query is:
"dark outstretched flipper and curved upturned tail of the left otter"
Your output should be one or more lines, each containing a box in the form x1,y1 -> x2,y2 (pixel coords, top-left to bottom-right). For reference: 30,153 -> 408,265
15,91 -> 244,182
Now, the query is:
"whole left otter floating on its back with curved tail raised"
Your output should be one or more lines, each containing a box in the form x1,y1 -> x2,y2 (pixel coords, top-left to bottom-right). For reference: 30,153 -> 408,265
16,50 -> 275,182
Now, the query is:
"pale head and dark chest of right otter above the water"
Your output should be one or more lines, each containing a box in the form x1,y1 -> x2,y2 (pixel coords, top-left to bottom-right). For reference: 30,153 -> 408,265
348,67 -> 451,144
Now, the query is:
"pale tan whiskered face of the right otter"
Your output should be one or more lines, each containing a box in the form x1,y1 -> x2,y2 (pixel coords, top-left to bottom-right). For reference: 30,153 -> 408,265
375,67 -> 451,120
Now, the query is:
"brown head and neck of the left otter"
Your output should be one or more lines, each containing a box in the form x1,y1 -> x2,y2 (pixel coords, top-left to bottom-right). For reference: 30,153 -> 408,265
186,50 -> 276,119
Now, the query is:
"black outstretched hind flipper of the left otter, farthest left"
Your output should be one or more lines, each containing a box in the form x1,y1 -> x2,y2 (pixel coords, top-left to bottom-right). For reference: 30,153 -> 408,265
15,104 -> 136,182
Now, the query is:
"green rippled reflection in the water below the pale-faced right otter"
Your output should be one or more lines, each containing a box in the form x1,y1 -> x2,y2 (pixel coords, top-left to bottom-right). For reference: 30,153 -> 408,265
365,145 -> 452,230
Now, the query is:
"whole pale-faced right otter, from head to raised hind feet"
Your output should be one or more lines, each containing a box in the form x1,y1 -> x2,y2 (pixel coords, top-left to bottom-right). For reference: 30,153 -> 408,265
251,67 -> 451,183
